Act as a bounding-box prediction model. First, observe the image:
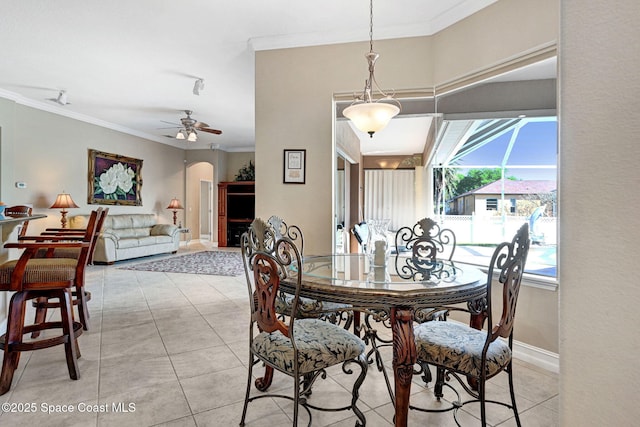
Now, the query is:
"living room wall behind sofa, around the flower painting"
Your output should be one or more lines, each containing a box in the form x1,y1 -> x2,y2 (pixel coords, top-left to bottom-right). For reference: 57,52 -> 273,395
0,99 -> 184,233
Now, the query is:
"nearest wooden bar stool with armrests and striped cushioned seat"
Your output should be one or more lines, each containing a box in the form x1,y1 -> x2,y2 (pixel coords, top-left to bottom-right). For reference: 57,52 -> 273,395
0,211 -> 97,395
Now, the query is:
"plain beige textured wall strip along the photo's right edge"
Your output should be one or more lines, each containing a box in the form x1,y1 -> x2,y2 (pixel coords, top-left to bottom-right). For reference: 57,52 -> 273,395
558,0 -> 640,426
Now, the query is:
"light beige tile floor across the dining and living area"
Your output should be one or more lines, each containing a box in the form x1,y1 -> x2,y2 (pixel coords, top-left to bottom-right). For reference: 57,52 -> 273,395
0,243 -> 559,427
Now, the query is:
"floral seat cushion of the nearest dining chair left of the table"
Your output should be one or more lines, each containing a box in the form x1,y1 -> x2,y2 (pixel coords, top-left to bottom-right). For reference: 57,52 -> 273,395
252,319 -> 365,374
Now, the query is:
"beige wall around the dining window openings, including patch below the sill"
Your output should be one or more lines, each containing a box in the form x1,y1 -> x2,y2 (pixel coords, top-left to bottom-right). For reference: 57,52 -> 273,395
256,0 -> 559,353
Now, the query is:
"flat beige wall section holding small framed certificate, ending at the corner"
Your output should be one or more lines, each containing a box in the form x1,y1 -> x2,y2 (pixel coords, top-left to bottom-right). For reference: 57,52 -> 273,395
256,37 -> 431,254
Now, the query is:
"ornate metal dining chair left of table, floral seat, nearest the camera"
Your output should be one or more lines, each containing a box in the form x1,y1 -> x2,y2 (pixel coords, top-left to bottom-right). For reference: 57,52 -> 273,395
240,218 -> 367,426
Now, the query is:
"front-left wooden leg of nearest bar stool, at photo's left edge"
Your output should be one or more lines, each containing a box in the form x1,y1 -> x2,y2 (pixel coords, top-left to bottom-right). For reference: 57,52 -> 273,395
0,292 -> 27,395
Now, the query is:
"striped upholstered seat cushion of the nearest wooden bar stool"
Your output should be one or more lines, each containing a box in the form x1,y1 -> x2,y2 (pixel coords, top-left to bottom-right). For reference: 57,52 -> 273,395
0,258 -> 78,288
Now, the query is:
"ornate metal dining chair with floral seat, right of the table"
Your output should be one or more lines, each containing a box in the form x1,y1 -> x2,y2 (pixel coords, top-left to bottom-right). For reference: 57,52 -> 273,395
411,223 -> 531,426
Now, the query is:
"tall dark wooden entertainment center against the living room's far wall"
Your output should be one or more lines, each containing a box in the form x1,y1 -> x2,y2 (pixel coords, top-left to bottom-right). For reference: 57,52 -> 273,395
218,181 -> 256,247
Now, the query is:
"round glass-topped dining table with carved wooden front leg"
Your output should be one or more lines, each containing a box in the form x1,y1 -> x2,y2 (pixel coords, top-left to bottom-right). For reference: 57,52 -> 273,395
280,254 -> 486,426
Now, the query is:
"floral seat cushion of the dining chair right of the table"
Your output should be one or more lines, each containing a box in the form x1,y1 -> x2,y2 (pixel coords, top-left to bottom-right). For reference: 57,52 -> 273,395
414,322 -> 511,377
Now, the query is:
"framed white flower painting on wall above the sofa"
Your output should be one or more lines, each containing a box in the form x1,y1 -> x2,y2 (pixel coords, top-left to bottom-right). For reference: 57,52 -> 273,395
88,149 -> 142,206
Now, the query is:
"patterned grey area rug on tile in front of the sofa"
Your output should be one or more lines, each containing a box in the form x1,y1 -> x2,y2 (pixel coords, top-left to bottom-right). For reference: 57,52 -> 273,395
120,251 -> 244,276
